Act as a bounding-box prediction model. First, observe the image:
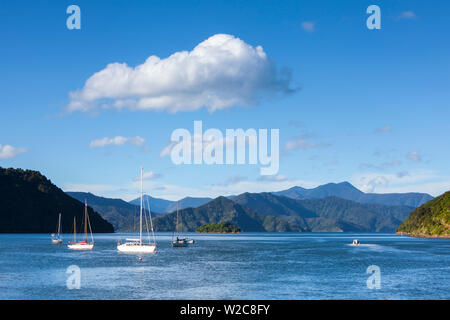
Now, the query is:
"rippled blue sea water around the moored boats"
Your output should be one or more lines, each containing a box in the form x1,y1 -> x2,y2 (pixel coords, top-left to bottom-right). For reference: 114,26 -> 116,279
0,233 -> 450,299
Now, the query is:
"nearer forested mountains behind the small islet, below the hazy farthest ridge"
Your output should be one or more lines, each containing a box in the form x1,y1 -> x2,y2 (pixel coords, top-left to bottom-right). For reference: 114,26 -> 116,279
154,193 -> 413,232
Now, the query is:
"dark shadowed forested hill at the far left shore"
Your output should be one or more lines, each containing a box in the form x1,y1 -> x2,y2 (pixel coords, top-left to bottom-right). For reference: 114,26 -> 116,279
0,167 -> 114,233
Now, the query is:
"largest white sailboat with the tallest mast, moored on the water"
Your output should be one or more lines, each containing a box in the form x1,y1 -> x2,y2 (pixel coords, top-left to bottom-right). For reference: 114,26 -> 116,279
117,167 -> 156,253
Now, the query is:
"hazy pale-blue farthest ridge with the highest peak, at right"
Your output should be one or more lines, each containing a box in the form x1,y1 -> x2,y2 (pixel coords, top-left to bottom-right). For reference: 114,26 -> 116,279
272,182 -> 433,208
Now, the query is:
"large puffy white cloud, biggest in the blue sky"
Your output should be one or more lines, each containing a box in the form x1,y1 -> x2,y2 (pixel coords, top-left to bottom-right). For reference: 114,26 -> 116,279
68,34 -> 293,112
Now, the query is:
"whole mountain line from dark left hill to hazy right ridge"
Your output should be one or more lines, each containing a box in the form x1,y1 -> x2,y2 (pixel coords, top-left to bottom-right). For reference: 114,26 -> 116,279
0,168 -> 432,232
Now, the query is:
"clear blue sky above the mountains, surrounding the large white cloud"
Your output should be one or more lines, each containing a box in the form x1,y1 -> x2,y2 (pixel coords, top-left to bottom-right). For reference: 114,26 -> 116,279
0,0 -> 450,200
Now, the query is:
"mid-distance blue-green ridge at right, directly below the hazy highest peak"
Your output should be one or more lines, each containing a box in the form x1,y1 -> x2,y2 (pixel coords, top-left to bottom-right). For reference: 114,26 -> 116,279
233,193 -> 413,232
